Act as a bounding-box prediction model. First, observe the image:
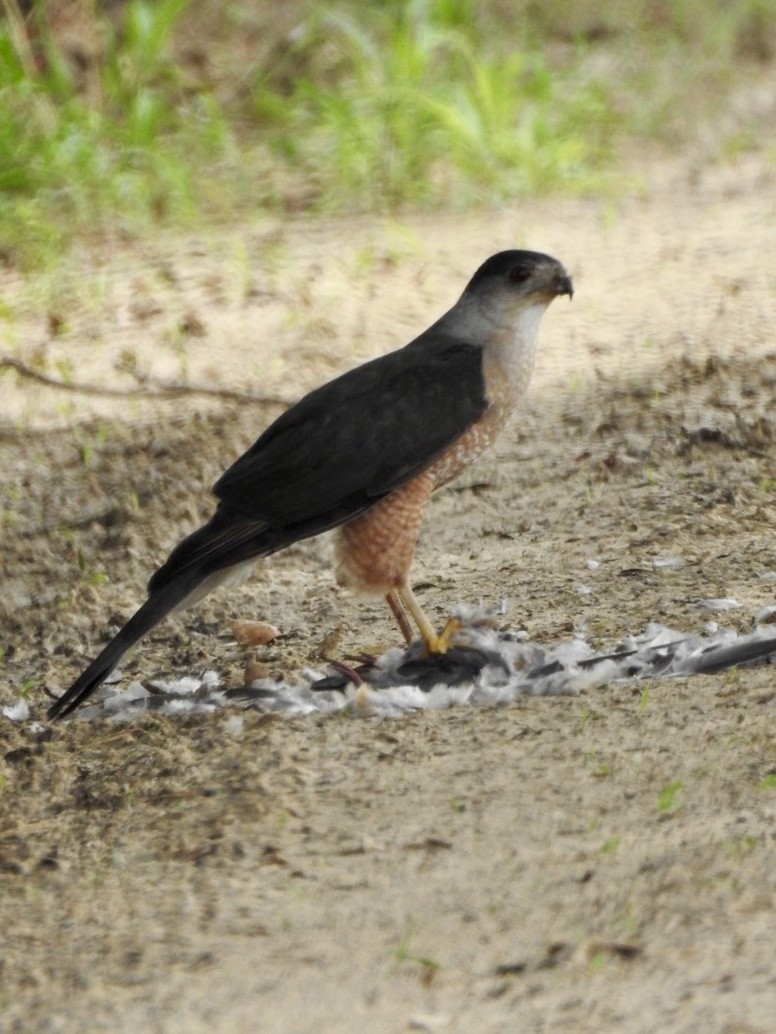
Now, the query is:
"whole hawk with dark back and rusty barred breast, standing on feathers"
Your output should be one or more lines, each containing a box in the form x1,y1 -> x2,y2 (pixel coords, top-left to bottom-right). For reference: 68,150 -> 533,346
49,251 -> 573,719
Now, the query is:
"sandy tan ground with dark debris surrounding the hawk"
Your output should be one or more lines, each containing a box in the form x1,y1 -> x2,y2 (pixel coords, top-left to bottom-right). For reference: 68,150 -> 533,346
0,149 -> 776,1034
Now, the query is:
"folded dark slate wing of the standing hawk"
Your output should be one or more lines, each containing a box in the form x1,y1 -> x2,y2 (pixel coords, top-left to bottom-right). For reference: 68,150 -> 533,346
149,328 -> 488,591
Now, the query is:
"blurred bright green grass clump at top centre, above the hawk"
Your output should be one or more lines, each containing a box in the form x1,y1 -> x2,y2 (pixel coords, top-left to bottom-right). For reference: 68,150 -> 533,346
251,3 -> 617,209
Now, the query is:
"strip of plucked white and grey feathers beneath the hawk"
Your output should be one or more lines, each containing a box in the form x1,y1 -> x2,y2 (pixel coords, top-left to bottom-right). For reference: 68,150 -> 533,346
41,611 -> 776,734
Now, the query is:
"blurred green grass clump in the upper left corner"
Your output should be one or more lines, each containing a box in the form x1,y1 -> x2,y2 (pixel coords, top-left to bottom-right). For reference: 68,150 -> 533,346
0,0 -> 235,261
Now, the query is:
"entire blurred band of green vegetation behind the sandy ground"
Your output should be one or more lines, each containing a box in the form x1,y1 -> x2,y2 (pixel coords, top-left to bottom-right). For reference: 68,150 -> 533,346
0,0 -> 776,265
